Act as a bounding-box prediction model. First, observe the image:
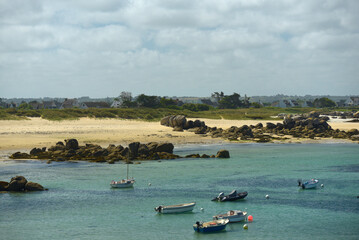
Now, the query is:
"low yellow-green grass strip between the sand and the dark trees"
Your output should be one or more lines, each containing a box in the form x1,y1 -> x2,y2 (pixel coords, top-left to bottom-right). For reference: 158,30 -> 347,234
0,107 -> 358,121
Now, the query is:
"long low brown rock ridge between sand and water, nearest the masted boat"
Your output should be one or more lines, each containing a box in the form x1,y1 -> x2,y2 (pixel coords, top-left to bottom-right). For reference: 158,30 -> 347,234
10,139 -> 230,164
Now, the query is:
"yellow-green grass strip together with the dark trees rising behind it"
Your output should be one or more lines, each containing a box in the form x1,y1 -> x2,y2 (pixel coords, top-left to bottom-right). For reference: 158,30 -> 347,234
0,92 -> 359,121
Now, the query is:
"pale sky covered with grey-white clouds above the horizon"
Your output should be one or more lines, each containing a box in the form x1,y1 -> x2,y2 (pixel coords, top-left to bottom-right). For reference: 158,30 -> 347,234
0,0 -> 359,98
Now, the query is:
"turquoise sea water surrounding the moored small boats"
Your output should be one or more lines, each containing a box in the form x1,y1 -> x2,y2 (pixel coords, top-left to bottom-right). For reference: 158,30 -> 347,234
0,144 -> 359,240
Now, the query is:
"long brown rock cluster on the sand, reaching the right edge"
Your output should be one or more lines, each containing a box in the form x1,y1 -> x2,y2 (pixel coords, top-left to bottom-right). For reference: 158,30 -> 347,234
161,112 -> 359,142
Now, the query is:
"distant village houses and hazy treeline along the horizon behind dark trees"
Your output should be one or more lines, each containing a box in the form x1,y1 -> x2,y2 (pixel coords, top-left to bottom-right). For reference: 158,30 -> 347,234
0,92 -> 359,109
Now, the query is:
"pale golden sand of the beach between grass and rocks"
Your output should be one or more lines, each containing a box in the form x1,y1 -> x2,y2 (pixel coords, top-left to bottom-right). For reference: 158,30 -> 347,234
0,118 -> 359,152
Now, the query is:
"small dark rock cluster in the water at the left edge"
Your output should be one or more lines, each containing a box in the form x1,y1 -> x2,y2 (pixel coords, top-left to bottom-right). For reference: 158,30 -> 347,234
0,176 -> 47,192
